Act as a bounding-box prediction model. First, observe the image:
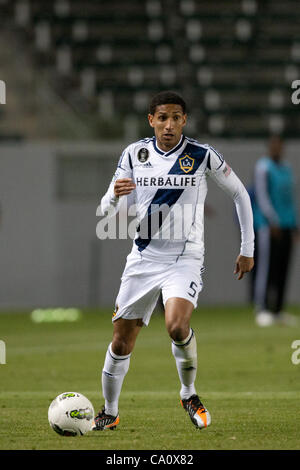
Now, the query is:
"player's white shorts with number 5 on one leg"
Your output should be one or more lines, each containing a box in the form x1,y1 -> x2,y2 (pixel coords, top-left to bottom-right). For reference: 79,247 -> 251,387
112,256 -> 203,325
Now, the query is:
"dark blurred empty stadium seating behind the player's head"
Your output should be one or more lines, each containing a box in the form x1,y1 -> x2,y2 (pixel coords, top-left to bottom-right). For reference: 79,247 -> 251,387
0,0 -> 300,137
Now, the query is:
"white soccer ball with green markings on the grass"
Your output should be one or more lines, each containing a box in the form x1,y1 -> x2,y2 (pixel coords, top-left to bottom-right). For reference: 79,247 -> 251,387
48,392 -> 95,436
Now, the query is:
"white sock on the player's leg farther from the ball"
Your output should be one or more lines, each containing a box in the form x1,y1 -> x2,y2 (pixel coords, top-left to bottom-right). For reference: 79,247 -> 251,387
172,329 -> 197,400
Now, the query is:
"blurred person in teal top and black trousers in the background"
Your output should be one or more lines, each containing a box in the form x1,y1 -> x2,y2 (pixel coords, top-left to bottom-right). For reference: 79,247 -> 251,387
251,136 -> 299,327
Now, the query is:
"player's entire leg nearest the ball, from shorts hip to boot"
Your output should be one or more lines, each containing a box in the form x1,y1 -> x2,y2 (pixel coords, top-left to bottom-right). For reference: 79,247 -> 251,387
95,258 -> 160,430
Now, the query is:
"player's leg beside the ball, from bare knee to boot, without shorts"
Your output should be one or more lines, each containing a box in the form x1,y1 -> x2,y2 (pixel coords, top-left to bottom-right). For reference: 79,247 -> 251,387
94,318 -> 143,430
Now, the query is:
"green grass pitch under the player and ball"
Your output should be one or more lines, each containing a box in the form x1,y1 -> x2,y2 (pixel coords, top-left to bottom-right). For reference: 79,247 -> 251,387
0,307 -> 300,450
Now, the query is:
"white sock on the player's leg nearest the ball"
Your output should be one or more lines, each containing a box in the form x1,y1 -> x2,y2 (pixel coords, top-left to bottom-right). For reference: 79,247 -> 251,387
102,343 -> 130,416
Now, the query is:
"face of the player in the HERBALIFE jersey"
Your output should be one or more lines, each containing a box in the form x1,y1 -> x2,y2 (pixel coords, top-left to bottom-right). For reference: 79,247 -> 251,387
148,104 -> 187,152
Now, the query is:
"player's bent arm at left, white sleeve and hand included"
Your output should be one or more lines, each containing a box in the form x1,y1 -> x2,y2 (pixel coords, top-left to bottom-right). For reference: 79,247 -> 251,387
97,147 -> 135,217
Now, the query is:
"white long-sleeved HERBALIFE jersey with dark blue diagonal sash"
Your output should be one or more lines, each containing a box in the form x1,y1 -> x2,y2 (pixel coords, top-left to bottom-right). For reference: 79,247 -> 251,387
101,135 -> 254,263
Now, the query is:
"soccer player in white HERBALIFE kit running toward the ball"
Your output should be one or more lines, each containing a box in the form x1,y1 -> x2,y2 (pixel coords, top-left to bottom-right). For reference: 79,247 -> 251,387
94,92 -> 254,430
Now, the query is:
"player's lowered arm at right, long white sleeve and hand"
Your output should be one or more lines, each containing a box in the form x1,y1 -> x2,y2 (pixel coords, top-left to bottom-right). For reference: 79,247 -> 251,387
207,149 -> 254,279
